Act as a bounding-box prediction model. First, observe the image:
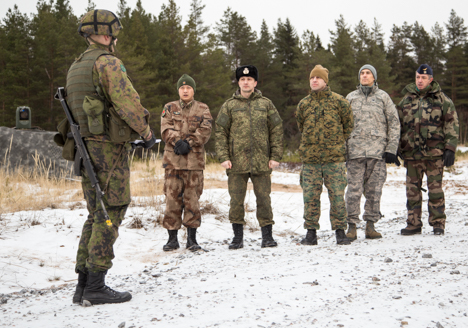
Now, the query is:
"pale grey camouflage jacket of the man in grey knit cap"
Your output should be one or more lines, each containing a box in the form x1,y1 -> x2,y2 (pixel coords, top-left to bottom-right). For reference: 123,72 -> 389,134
346,85 -> 400,159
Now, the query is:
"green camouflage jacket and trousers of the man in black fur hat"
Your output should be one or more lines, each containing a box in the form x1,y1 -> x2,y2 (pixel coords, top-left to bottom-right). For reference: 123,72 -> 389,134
216,90 -> 283,227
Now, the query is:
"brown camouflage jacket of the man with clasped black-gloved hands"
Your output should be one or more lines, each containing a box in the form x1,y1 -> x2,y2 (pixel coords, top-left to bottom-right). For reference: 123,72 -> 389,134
161,100 -> 213,170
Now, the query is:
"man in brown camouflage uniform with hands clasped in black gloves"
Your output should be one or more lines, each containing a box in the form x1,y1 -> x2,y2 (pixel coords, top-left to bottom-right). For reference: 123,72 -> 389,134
161,74 -> 213,251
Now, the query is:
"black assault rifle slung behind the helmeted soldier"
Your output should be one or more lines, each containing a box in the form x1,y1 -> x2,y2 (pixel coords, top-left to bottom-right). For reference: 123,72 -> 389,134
55,87 -> 110,222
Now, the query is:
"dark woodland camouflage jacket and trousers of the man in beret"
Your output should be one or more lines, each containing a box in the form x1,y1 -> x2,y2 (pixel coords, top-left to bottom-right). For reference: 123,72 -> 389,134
397,81 -> 459,229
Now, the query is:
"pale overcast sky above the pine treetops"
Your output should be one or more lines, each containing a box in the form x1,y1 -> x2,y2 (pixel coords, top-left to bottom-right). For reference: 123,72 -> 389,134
0,0 -> 468,46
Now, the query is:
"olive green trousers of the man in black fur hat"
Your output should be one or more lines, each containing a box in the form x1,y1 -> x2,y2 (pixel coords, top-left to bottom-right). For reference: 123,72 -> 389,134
228,172 -> 275,227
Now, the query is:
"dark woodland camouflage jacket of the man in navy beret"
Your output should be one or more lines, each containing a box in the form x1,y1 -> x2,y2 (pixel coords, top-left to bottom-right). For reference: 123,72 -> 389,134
397,81 -> 459,160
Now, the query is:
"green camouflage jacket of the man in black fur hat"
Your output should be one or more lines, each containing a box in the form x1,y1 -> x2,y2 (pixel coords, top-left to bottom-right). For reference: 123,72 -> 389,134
216,89 -> 283,174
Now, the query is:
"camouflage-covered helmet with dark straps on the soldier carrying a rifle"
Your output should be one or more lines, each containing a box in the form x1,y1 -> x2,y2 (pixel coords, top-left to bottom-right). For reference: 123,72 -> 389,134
78,9 -> 123,38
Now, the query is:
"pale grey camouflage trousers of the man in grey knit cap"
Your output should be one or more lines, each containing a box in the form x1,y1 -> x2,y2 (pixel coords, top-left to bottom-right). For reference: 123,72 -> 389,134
346,158 -> 387,224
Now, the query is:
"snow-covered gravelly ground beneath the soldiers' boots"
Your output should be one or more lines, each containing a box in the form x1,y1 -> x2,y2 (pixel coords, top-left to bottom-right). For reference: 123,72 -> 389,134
0,161 -> 468,328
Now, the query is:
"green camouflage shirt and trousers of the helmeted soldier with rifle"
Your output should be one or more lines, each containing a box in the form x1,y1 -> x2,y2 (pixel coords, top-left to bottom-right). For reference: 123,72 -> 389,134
67,45 -> 150,272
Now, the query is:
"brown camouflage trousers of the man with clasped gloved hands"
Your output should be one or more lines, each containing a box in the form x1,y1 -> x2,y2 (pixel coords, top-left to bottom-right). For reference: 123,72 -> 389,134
163,169 -> 204,230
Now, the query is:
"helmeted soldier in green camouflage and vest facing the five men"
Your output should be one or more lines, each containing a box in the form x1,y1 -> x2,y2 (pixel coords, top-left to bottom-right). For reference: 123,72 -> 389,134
66,9 -> 155,304
